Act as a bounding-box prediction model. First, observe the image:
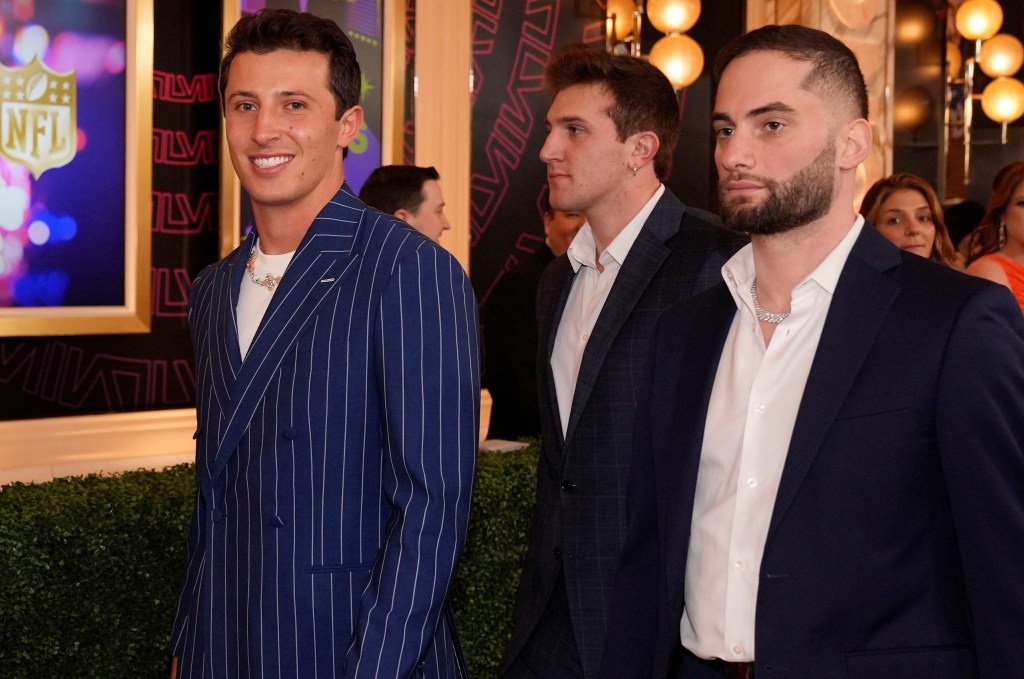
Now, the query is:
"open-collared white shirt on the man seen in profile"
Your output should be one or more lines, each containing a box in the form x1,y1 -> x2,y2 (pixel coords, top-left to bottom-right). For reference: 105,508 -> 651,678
551,184 -> 665,435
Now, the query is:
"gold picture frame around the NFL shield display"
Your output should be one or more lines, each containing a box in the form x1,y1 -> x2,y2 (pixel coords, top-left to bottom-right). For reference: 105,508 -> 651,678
0,0 -> 154,337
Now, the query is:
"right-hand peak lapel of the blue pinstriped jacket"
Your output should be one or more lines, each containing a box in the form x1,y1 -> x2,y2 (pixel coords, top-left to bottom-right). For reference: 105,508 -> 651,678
198,184 -> 364,489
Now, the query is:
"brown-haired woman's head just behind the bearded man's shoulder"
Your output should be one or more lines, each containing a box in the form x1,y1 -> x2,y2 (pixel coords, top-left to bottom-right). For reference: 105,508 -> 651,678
860,172 -> 957,267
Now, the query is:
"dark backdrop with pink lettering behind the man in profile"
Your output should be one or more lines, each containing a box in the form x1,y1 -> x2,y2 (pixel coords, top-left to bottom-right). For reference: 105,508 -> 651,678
470,0 -> 745,304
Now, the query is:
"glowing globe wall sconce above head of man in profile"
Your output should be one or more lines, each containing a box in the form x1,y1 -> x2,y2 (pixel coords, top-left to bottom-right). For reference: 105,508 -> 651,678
604,0 -> 703,90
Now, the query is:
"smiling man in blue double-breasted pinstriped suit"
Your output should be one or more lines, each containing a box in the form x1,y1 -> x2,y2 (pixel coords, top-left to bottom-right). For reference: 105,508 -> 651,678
171,10 -> 479,679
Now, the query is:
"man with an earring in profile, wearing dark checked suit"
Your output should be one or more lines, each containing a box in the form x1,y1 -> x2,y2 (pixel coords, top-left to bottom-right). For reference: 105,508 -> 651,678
502,46 -> 745,679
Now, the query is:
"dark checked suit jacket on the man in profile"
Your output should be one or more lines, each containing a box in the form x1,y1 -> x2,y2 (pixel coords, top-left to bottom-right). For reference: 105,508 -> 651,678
503,190 -> 746,677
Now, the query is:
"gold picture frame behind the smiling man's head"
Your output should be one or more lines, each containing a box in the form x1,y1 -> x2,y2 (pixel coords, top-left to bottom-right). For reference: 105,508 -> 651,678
219,0 -> 406,257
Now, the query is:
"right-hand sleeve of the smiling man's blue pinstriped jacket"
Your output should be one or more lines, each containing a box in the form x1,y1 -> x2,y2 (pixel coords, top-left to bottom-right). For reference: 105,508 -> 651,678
345,244 -> 480,679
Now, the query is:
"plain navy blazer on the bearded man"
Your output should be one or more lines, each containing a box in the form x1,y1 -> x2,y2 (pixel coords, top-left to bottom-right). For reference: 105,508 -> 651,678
601,225 -> 1024,679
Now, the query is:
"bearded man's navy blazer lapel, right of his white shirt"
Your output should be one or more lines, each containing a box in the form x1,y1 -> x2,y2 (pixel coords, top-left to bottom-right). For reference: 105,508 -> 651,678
768,223 -> 900,540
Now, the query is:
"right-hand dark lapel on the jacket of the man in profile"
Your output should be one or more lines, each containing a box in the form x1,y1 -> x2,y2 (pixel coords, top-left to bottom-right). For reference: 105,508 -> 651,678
561,189 -> 683,448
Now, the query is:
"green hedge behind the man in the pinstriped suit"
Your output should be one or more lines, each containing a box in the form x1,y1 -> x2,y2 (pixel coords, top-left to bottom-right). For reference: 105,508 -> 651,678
0,445 -> 537,679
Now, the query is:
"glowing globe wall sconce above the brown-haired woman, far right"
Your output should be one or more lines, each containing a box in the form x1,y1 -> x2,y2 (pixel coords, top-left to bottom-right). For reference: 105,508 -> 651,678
945,0 -> 1024,185
